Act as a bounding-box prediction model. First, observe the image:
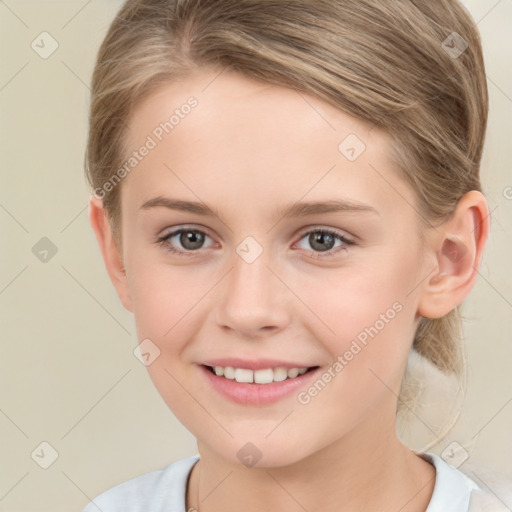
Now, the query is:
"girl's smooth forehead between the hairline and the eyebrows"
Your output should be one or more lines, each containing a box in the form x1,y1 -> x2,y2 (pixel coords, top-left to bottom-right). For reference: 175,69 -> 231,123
123,70 -> 416,222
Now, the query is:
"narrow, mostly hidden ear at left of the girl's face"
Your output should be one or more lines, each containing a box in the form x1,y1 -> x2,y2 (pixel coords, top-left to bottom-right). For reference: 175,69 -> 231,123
89,195 -> 133,311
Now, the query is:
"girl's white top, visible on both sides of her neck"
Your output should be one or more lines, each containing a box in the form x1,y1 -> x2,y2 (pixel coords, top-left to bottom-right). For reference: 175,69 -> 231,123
83,453 -> 510,512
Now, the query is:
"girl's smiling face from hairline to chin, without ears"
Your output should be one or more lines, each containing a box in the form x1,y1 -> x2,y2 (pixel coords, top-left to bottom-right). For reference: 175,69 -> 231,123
114,67 -> 428,466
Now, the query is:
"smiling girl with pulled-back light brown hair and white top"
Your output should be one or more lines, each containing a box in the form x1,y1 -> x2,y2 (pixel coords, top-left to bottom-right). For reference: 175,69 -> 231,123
84,0 -> 506,512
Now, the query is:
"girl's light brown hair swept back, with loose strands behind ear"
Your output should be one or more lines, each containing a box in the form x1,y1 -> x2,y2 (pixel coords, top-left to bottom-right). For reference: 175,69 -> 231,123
85,0 -> 488,448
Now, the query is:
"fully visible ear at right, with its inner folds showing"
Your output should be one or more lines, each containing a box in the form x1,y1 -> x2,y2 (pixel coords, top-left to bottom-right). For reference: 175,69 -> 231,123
418,190 -> 490,318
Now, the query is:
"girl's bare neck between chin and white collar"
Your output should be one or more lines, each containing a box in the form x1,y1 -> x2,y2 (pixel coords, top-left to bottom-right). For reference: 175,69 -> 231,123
187,412 -> 435,512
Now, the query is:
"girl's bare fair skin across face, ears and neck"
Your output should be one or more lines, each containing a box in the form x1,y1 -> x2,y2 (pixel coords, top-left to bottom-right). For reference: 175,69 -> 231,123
90,69 -> 489,512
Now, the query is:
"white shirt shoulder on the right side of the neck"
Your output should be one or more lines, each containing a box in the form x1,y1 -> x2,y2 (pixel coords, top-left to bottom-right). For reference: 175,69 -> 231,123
418,453 -> 512,512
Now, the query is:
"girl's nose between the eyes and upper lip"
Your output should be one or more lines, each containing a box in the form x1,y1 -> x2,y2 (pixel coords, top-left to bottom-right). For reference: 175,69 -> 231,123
215,237 -> 288,334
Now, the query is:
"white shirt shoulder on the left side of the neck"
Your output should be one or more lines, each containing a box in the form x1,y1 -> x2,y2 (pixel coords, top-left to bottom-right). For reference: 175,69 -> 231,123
83,455 -> 199,512
